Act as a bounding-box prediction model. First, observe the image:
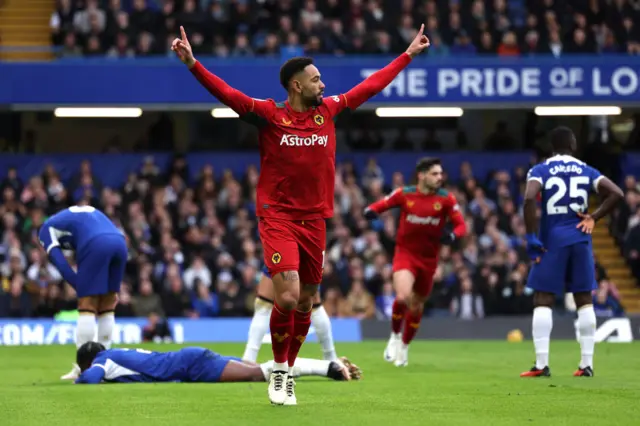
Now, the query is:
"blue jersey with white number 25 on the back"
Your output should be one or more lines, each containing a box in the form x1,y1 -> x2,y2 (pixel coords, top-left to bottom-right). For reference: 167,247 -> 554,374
527,155 -> 603,249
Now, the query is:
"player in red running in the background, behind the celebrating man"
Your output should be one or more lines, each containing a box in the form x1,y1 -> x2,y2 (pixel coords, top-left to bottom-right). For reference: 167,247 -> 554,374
365,158 -> 467,367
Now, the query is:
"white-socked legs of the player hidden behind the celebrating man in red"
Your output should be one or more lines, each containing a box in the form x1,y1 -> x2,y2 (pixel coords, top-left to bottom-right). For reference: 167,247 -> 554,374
242,267 -> 338,362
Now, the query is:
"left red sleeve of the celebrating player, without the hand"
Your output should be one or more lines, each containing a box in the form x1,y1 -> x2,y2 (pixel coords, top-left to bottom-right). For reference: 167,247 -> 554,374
191,61 -> 272,118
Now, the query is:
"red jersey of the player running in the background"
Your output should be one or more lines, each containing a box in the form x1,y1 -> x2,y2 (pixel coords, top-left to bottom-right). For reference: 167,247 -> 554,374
369,186 -> 466,262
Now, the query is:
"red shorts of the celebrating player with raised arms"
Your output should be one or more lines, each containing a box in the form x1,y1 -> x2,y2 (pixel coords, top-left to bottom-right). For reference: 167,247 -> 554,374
258,218 -> 327,284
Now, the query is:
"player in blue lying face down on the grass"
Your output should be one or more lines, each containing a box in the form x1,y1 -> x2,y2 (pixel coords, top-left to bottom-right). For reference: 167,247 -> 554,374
76,342 -> 362,384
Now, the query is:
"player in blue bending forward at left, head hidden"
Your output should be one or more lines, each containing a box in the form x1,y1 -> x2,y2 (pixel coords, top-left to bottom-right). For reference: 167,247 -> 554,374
38,206 -> 127,380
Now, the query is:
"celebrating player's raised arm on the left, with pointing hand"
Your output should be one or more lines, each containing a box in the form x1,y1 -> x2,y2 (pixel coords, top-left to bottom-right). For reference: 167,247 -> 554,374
171,27 -> 270,117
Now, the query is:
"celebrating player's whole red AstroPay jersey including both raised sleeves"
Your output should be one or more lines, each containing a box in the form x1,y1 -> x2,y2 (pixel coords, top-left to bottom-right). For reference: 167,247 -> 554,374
191,53 -> 411,220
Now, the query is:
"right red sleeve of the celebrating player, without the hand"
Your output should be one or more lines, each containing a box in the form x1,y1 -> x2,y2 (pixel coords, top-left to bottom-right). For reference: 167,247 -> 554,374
325,53 -> 411,116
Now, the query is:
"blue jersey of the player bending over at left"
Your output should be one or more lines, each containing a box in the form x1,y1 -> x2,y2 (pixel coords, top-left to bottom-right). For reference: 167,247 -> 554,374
38,206 -> 122,253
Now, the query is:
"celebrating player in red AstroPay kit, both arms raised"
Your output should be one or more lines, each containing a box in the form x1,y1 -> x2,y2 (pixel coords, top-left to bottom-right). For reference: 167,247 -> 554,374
171,26 -> 429,405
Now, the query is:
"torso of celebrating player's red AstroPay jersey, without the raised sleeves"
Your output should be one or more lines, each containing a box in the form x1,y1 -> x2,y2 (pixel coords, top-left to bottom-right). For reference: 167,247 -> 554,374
254,95 -> 347,220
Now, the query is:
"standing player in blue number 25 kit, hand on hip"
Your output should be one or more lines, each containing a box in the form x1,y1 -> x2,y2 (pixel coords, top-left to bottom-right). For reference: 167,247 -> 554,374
520,127 -> 623,377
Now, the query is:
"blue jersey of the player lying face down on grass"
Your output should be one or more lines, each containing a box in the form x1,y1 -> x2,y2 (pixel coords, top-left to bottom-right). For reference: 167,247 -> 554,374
78,349 -> 193,384
